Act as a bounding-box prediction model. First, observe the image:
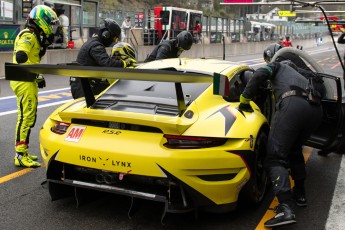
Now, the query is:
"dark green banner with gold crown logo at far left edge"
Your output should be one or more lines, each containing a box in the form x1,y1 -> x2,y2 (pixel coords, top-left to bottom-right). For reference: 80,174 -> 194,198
0,24 -> 20,51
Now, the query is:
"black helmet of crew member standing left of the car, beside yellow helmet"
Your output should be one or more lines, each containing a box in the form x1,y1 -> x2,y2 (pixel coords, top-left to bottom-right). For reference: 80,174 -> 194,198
98,18 -> 121,46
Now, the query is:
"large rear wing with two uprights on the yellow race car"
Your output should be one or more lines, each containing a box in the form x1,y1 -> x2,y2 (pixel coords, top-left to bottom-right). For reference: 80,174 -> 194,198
5,63 -> 229,115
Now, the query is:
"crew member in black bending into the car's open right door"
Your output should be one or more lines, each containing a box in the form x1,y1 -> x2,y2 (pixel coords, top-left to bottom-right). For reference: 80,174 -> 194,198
239,58 -> 324,227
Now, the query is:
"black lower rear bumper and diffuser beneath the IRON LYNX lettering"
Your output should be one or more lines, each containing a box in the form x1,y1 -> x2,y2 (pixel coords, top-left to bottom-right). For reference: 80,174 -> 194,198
47,161 -> 242,213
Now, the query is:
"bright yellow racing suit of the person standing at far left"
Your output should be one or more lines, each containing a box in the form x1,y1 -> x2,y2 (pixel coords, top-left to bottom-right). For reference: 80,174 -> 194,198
10,29 -> 41,154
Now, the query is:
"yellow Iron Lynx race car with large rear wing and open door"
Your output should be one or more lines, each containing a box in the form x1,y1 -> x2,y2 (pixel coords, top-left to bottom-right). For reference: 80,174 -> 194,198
5,50 -> 344,217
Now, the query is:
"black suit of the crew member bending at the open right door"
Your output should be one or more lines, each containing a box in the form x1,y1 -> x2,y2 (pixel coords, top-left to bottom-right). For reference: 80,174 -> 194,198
243,62 -> 323,203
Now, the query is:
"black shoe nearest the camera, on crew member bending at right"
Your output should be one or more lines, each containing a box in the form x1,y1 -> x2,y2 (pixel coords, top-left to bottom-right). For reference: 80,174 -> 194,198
264,203 -> 296,228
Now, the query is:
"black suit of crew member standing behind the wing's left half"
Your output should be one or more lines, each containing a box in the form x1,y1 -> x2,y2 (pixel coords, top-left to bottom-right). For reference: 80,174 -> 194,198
70,36 -> 124,99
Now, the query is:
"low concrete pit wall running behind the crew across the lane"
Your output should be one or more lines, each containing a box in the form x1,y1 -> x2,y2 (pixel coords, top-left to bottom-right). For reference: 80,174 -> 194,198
0,36 -> 331,77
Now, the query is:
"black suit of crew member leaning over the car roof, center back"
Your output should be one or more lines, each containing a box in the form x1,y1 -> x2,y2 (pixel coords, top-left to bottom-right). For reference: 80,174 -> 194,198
144,39 -> 181,62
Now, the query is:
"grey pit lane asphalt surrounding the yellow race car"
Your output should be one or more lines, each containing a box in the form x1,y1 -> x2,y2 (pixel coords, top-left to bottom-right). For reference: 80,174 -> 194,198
0,42 -> 345,230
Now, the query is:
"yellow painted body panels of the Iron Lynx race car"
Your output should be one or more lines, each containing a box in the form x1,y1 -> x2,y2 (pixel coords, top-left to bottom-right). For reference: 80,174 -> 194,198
39,59 -> 267,207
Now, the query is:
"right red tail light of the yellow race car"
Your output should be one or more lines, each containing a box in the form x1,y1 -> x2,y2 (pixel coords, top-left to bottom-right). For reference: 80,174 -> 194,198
164,134 -> 227,149
